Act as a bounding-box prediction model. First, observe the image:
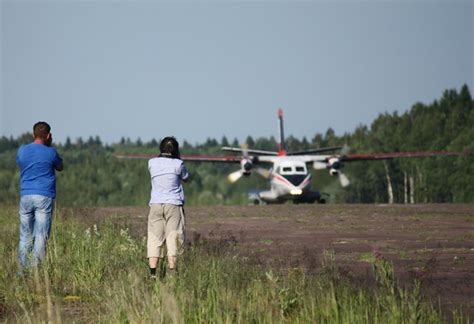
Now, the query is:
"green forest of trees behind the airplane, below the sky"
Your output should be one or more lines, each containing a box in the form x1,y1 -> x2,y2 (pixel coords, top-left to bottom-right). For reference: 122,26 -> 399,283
0,85 -> 474,206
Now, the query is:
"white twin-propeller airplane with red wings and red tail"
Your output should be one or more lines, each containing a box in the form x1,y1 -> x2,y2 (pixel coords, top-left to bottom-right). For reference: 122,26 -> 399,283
116,109 -> 465,203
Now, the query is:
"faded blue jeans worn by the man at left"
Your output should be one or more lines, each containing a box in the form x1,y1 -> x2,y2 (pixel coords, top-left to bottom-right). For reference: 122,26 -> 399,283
18,195 -> 54,269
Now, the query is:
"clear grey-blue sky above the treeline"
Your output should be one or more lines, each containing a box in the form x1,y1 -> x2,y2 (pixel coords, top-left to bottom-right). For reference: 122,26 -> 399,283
0,0 -> 474,144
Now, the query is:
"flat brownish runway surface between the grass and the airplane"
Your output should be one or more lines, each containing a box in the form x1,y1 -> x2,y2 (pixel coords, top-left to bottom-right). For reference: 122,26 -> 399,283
70,204 -> 474,319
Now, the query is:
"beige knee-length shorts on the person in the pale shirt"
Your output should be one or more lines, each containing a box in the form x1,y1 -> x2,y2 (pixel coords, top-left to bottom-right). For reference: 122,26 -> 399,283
147,204 -> 186,258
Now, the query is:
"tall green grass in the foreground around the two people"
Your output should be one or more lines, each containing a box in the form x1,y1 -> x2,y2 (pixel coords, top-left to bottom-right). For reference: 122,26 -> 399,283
0,206 -> 468,323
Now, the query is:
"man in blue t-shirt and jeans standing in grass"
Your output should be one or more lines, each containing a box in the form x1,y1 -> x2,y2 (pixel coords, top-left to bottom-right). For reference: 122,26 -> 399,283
16,122 -> 63,269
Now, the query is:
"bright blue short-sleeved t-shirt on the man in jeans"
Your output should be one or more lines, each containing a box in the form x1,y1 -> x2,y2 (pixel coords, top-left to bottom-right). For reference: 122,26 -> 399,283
16,143 -> 62,198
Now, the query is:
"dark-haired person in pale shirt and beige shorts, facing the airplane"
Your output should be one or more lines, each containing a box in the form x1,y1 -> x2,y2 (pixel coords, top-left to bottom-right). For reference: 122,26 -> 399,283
147,136 -> 189,280
